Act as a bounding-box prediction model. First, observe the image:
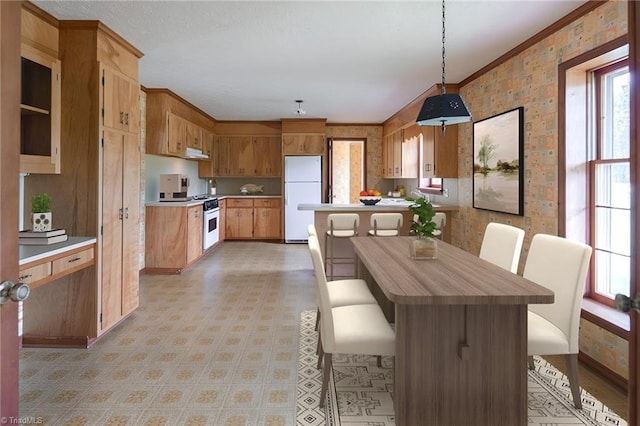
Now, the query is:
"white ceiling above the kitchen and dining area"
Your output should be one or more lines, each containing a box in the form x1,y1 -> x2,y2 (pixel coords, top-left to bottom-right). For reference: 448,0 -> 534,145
34,0 -> 586,123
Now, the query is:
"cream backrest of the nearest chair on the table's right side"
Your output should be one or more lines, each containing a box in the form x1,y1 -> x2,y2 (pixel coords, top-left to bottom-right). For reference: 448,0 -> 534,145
522,234 -> 591,353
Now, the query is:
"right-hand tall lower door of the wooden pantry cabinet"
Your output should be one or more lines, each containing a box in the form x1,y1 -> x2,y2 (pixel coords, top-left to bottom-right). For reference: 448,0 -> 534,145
122,134 -> 141,316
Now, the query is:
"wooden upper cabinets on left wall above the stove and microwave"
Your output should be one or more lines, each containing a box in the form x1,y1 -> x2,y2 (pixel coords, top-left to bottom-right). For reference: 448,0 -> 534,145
146,89 -> 215,160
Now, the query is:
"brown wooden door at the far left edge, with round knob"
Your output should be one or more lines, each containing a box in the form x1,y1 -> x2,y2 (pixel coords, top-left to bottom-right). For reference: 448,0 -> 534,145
0,1 -> 22,420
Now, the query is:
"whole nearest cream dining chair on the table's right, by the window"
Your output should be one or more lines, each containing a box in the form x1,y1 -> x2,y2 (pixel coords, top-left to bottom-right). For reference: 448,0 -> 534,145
522,234 -> 592,408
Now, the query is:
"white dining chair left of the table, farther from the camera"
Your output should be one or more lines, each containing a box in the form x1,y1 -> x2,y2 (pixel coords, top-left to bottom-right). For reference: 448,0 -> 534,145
308,235 -> 378,330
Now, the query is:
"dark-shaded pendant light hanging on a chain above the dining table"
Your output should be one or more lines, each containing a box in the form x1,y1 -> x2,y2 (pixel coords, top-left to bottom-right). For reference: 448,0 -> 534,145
416,0 -> 471,133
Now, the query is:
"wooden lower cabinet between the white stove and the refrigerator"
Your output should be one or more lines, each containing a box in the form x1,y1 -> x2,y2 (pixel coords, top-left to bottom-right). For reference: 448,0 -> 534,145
225,198 -> 282,240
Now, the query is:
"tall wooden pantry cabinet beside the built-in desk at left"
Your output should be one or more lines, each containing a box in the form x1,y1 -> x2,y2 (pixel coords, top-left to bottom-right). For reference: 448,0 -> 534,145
24,21 -> 142,347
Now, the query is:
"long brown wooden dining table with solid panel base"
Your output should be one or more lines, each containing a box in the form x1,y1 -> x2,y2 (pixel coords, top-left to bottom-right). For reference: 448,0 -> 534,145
351,237 -> 554,426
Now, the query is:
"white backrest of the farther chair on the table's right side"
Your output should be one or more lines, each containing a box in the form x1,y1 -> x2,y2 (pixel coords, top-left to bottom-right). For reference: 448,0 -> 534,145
479,222 -> 524,274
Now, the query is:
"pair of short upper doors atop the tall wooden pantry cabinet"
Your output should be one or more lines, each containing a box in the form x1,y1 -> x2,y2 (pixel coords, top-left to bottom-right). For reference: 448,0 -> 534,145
102,66 -> 140,133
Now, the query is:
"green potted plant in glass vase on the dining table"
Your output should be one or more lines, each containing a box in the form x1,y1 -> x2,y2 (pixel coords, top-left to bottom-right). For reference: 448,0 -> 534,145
406,197 -> 438,259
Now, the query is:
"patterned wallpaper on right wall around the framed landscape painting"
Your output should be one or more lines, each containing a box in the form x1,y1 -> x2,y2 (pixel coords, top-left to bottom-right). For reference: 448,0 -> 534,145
451,1 -> 628,377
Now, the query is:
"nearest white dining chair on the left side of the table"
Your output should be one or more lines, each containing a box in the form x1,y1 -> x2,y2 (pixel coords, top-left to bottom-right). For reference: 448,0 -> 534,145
309,237 -> 395,407
